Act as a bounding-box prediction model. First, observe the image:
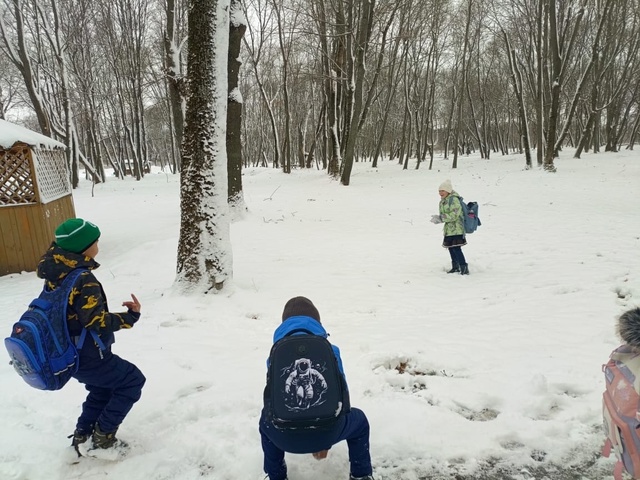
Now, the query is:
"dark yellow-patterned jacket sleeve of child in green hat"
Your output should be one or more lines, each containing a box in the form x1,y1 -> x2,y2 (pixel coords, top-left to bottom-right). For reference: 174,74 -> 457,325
69,271 -> 140,335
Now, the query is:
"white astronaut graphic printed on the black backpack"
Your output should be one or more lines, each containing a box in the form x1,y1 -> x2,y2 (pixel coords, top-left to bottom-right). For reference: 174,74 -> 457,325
284,358 -> 328,410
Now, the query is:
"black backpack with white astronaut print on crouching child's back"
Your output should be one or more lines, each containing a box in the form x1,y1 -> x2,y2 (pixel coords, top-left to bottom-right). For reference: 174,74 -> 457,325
264,329 -> 350,430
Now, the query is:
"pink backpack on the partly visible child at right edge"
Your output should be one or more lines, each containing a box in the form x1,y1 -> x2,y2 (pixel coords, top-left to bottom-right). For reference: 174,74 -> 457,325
602,345 -> 640,480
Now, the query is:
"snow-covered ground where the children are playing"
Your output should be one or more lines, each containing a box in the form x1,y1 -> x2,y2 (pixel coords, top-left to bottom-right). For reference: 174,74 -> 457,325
0,151 -> 640,480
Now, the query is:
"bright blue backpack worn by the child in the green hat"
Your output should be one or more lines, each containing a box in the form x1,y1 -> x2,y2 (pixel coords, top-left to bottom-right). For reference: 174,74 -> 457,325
4,269 -> 104,390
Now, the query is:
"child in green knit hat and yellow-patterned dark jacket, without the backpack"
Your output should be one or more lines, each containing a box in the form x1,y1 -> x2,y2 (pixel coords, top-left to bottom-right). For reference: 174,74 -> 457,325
38,218 -> 145,455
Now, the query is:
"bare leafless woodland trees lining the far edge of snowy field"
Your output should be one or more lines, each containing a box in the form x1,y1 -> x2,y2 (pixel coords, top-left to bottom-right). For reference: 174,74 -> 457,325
0,0 -> 640,186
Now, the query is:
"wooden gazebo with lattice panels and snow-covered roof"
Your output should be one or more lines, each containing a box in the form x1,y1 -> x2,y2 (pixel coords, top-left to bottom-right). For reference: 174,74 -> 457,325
0,120 -> 76,275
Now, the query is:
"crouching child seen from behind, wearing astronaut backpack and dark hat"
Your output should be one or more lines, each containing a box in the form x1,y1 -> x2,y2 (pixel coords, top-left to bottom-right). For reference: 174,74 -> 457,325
260,297 -> 373,480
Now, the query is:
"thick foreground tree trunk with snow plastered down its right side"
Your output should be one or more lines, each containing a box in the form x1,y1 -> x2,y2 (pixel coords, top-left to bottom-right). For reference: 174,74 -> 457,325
176,0 -> 232,292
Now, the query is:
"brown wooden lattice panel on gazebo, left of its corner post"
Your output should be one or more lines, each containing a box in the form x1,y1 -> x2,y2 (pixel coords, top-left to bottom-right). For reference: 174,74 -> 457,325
0,146 -> 36,206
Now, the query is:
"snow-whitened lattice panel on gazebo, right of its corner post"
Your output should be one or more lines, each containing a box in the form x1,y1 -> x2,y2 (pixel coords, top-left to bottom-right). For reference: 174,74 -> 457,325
33,150 -> 71,203
